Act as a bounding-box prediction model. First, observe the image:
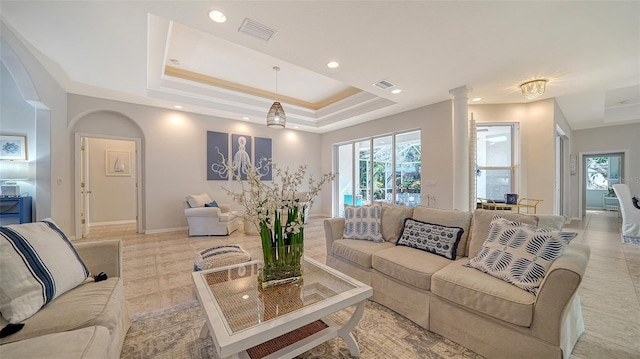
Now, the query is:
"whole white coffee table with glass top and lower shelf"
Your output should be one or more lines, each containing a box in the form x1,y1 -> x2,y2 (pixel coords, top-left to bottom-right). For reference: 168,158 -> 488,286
193,258 -> 373,359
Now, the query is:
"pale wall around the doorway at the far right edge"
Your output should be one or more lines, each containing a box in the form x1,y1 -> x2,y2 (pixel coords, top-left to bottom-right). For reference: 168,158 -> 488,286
571,123 -> 640,218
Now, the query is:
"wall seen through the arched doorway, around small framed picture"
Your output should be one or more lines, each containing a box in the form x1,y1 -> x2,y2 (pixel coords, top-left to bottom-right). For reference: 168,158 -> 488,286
87,138 -> 137,225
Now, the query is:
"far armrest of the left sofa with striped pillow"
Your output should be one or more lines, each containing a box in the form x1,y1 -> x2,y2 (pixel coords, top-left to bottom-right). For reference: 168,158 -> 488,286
73,239 -> 123,278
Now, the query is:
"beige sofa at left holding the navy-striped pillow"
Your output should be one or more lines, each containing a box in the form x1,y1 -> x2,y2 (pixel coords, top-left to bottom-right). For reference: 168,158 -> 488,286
0,240 -> 131,359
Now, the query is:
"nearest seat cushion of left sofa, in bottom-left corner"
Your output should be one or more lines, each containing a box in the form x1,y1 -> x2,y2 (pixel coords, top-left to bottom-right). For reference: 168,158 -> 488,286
0,327 -> 111,359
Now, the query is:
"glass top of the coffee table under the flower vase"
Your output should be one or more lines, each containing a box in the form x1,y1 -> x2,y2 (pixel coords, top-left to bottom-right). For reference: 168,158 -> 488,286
202,258 -> 367,335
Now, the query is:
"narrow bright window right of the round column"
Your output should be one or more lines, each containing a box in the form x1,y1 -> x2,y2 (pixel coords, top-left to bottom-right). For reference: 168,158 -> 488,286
476,124 -> 518,200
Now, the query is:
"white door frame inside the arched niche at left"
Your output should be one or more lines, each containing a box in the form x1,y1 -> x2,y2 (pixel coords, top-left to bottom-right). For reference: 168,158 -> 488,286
73,132 -> 144,239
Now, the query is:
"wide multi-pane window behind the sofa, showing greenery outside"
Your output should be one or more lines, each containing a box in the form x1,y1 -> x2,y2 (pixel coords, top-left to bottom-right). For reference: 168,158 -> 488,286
334,131 -> 421,216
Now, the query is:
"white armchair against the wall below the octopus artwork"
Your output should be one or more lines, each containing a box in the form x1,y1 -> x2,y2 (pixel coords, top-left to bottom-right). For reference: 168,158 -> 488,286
184,193 -> 240,236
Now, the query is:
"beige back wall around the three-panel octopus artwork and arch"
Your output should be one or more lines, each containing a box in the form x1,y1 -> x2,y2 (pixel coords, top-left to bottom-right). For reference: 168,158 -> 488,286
67,94 -> 322,232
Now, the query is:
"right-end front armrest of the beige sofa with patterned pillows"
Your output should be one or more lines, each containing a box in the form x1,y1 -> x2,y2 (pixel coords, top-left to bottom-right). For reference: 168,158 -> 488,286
531,243 -> 591,345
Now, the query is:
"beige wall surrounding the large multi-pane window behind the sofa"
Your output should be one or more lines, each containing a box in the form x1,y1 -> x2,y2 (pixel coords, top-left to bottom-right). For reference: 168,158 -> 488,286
320,101 -> 453,214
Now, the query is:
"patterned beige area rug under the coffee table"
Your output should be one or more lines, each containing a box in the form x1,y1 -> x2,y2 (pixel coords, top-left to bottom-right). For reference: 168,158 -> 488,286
121,301 -> 482,359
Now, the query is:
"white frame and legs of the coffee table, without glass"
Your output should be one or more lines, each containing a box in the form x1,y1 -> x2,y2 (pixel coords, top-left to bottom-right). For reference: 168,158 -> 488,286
193,258 -> 373,359
